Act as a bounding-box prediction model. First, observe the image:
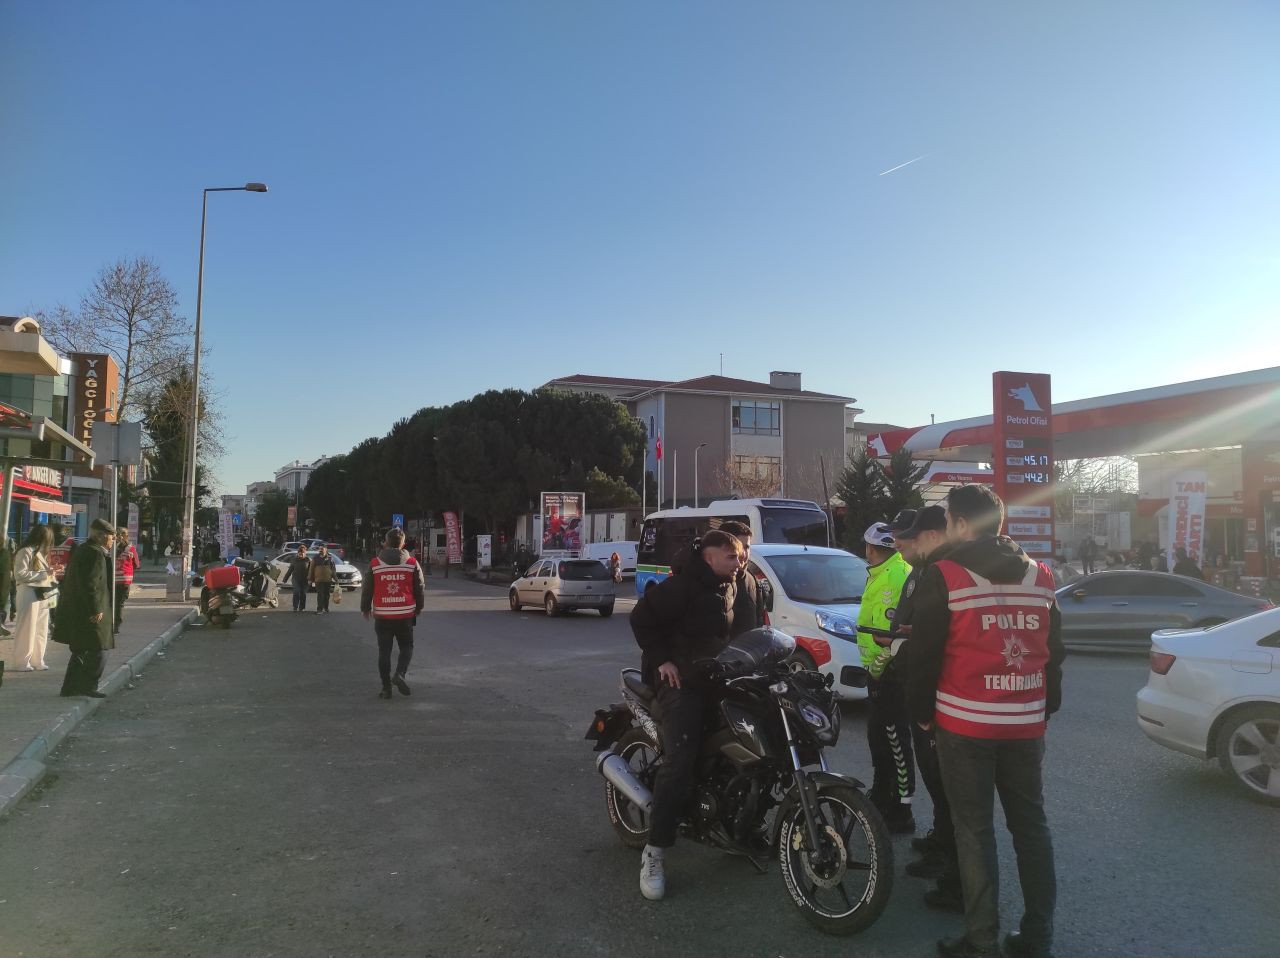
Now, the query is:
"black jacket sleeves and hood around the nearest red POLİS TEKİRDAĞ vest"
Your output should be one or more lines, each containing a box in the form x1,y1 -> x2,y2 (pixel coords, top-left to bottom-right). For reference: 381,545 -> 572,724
906,535 -> 1066,724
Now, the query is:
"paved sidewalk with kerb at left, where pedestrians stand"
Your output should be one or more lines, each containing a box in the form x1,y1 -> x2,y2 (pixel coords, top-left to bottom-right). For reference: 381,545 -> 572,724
0,584 -> 193,816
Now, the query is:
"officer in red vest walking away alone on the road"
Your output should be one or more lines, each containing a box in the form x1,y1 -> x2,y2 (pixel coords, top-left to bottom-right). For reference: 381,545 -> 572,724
360,528 -> 426,698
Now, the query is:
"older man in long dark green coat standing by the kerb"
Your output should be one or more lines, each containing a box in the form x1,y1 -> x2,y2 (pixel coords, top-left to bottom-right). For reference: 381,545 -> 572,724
54,519 -> 115,698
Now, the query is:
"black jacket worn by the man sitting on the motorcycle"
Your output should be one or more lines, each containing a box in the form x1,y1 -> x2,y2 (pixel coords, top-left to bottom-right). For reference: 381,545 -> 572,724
631,556 -> 737,685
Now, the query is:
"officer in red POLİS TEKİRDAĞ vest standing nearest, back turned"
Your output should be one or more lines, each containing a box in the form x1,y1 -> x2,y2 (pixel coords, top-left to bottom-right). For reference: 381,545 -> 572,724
908,485 -> 1066,958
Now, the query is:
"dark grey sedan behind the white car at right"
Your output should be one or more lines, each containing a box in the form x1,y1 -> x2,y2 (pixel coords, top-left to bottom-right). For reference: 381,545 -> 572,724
1057,570 -> 1271,652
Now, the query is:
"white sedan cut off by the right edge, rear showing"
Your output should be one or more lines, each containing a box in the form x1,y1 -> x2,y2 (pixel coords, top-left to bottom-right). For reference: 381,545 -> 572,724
1138,608 -> 1280,806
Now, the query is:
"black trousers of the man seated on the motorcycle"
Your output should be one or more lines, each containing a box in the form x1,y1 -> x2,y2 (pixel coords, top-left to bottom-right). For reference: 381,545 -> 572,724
649,683 -> 707,848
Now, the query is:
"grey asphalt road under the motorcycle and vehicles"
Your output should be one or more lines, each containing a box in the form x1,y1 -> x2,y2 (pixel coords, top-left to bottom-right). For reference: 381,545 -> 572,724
0,578 -> 1277,958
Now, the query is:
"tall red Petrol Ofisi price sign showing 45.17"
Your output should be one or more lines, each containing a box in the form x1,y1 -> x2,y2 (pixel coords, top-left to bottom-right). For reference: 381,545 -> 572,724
991,371 -> 1057,558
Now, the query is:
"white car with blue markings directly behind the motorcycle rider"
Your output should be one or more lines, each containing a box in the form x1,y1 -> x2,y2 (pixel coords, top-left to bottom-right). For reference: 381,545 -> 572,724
748,543 -> 867,699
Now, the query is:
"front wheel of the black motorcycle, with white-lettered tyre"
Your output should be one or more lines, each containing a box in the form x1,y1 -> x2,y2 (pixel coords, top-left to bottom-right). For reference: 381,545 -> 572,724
778,785 -> 893,935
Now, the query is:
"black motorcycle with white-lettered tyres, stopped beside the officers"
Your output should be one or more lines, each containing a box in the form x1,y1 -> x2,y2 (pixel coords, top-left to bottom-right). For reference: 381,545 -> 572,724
586,626 -> 893,935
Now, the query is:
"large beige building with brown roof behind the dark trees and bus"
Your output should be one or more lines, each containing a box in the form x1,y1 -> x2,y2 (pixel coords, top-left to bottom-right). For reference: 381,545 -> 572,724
545,371 -> 856,507
